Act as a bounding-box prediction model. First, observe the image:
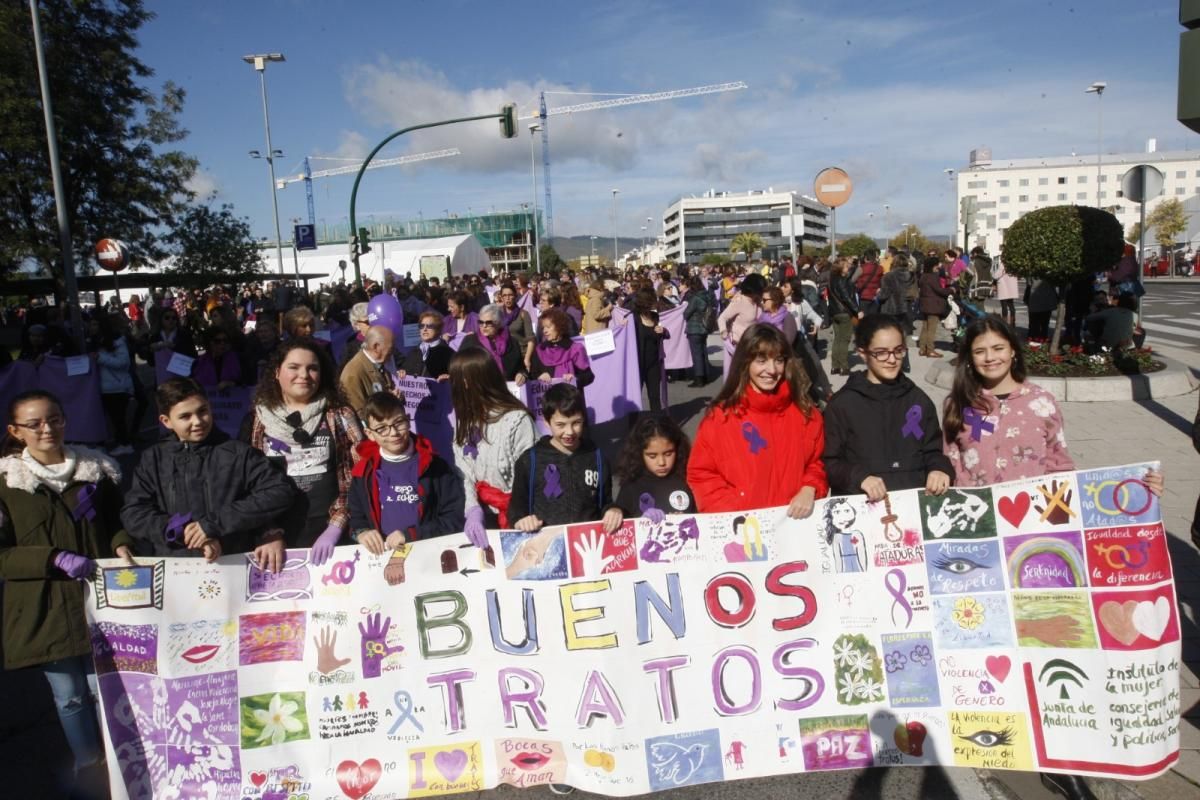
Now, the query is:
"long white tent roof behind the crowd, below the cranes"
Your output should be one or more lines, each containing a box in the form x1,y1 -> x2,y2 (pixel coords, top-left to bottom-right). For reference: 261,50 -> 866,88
288,234 -> 492,281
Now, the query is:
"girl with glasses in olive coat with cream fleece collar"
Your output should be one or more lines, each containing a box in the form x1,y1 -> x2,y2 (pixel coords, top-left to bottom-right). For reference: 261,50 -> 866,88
0,391 -> 133,786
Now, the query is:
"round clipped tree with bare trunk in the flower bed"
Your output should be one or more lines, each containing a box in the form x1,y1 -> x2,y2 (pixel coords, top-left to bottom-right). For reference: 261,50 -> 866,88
1001,205 -> 1124,353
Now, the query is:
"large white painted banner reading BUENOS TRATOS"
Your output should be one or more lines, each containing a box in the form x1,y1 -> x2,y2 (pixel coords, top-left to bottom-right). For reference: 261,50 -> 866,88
89,464 -> 1180,800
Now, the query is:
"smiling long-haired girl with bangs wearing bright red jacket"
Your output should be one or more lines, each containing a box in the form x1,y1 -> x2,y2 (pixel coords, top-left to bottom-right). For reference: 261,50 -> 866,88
688,323 -> 829,519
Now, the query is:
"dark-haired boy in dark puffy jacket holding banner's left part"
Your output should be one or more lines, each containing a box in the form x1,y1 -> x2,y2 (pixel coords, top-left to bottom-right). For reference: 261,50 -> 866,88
121,378 -> 295,572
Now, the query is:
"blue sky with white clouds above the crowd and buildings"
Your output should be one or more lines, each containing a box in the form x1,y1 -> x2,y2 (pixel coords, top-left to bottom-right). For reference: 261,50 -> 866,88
140,0 -> 1185,244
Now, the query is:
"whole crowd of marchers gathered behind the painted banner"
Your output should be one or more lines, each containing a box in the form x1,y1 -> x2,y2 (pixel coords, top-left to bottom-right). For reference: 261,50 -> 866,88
0,248 -> 1185,798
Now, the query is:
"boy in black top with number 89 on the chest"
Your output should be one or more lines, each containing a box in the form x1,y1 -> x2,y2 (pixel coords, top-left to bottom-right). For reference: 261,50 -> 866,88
509,384 -> 624,534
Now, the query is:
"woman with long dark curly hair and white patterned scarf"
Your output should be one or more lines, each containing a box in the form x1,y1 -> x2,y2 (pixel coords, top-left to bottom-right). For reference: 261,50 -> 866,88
241,338 -> 362,566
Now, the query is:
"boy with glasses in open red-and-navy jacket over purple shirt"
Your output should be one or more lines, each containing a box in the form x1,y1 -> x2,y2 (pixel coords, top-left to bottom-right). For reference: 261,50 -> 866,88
350,392 -> 464,555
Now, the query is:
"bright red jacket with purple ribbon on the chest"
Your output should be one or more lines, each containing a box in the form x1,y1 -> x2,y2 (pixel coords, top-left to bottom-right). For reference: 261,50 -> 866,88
688,383 -> 829,513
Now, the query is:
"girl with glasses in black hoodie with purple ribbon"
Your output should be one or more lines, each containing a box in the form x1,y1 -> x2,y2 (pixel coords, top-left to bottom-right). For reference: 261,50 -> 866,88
824,314 -> 954,503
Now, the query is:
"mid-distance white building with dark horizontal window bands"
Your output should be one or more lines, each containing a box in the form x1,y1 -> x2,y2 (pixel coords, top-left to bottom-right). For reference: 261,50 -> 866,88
662,188 -> 829,264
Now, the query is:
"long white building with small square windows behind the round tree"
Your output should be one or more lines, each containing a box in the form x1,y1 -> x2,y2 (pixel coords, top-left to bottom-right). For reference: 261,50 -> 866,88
954,140 -> 1200,252
